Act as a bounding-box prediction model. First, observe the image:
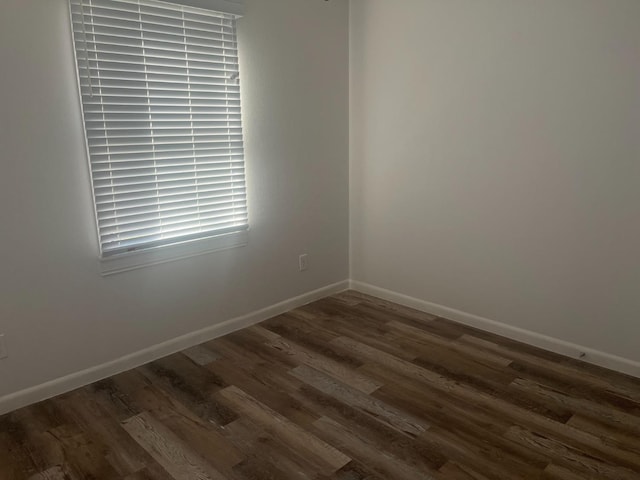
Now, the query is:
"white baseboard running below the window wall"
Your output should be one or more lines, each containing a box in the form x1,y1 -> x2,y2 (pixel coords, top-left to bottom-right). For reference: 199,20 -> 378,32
0,280 -> 349,415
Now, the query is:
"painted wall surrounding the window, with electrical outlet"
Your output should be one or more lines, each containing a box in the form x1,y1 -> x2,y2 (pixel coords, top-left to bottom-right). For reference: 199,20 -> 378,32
0,0 -> 349,397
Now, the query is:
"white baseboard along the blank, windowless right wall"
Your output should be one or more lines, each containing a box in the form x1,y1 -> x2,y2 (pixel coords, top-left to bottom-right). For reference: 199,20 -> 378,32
349,280 -> 640,378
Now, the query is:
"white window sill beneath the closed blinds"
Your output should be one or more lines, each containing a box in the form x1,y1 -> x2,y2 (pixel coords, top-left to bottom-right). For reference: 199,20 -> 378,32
100,230 -> 249,276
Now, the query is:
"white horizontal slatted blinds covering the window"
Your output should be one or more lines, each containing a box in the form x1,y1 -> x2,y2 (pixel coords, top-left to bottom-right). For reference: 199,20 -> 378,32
70,0 -> 247,257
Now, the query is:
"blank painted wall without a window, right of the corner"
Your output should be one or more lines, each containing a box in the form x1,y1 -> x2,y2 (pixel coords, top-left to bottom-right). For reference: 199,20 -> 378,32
350,0 -> 640,361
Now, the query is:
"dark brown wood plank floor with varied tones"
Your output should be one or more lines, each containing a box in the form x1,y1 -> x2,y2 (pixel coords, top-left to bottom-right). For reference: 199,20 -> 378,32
0,292 -> 640,480
